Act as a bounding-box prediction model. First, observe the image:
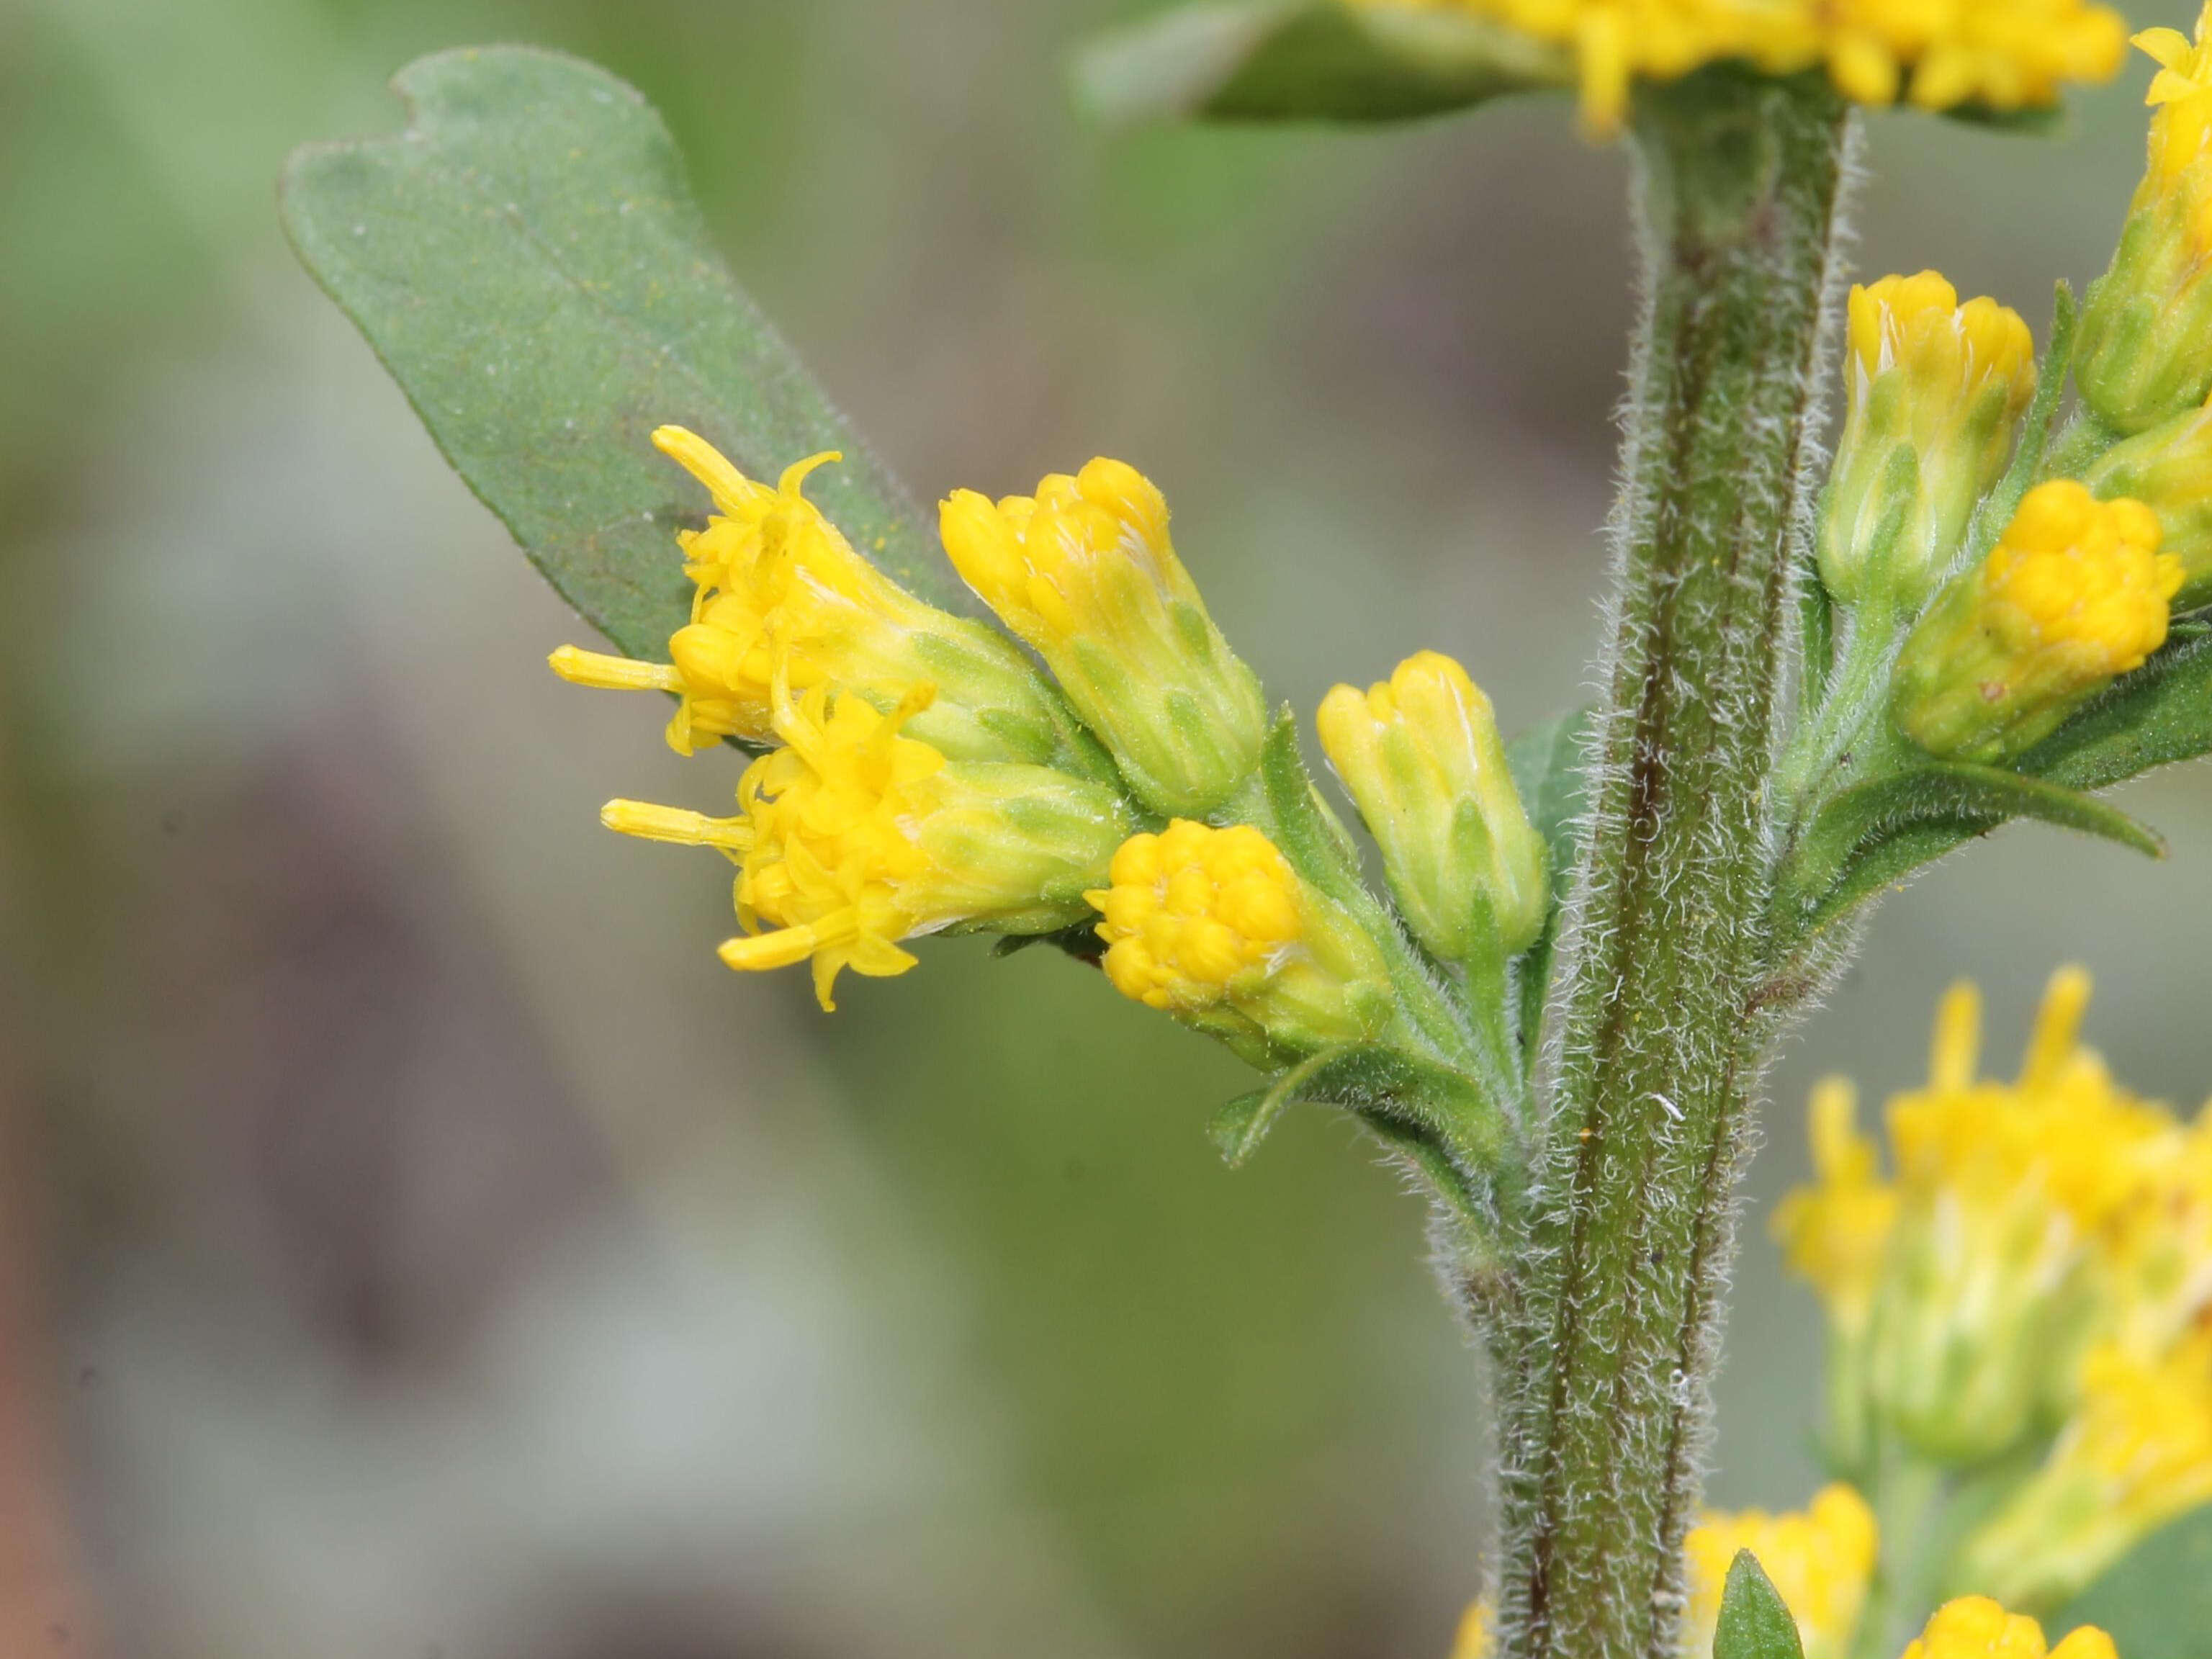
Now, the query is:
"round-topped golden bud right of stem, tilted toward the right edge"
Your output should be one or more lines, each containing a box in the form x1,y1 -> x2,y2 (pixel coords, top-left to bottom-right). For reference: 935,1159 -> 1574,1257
1892,480 -> 2181,761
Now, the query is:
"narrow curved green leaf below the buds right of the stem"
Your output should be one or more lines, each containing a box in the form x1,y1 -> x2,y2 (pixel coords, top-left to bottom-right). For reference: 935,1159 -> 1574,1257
1785,761 -> 2165,925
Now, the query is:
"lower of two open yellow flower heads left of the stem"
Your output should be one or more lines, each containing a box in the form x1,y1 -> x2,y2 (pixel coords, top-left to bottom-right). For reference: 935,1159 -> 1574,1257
602,683 -> 1128,1009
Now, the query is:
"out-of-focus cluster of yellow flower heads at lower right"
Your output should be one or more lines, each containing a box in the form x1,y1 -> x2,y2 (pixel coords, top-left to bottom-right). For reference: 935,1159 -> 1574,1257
1774,969 -> 2212,1606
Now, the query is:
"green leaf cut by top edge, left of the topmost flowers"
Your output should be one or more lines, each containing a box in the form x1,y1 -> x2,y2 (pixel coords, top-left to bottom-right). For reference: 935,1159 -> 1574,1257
1075,0 -> 1573,122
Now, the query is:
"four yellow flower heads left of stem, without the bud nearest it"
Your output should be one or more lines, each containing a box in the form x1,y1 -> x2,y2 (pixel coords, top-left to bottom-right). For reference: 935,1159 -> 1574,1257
553,427 -> 1416,1064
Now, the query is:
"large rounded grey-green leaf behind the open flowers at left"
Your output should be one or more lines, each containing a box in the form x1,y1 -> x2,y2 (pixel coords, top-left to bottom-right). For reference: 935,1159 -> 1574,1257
281,47 -> 949,659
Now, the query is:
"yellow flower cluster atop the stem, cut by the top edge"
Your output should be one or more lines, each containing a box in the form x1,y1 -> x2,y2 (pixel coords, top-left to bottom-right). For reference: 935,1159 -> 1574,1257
1370,0 -> 2126,130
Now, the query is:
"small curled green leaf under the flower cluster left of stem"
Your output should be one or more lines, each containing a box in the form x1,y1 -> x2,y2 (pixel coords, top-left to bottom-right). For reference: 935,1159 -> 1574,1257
1205,1042 -> 1504,1190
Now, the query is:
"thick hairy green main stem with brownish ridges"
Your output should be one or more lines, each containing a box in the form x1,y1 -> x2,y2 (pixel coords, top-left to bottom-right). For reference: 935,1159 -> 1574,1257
1498,73 -> 1847,1659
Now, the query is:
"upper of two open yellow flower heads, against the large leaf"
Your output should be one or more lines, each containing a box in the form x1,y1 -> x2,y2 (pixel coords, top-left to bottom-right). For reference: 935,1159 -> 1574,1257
551,427 -> 1057,761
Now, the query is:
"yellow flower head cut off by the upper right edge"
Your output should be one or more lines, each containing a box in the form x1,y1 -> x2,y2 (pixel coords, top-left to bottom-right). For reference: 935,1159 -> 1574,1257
2075,6 -> 2212,431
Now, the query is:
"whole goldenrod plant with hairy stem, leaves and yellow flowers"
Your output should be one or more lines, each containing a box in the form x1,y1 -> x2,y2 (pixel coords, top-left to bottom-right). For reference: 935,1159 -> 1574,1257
283,0 -> 2212,1659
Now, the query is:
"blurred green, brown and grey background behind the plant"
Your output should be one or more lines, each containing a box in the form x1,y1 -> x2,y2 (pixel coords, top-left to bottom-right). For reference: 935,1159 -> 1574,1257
0,0 -> 2212,1659
